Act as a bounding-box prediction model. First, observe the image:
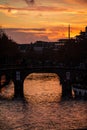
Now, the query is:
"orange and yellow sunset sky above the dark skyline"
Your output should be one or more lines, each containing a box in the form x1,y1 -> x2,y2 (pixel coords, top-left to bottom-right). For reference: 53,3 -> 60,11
0,0 -> 87,43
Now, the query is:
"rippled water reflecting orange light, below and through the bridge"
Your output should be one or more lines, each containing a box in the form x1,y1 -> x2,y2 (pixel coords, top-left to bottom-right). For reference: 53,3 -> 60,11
0,74 -> 87,130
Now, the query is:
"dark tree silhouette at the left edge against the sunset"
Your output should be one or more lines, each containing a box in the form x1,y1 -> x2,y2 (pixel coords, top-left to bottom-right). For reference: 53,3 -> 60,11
0,30 -> 19,65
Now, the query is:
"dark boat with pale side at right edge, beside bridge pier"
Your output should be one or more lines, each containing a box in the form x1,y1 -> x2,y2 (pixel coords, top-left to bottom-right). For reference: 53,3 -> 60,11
72,84 -> 87,98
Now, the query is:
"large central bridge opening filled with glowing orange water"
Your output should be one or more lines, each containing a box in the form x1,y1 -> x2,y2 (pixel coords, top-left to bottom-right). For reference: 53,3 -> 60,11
23,73 -> 62,102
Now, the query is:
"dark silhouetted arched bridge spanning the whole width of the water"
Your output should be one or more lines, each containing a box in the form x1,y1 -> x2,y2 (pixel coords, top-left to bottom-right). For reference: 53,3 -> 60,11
0,65 -> 87,97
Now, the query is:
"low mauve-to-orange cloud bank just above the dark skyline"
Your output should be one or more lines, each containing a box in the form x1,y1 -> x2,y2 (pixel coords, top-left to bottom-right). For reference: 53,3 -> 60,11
4,25 -> 80,44
